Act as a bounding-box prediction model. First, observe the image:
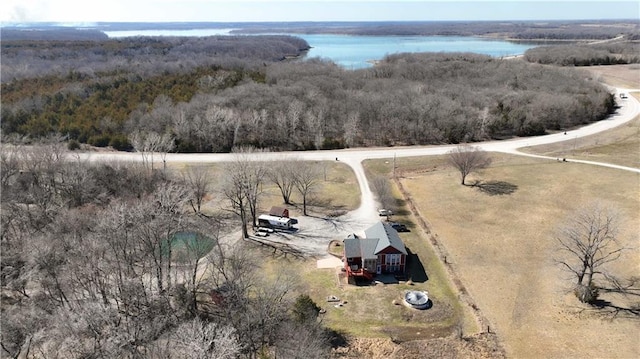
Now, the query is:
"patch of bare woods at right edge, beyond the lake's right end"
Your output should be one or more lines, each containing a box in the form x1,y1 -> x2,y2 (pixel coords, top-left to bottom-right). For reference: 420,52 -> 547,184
524,42 -> 640,66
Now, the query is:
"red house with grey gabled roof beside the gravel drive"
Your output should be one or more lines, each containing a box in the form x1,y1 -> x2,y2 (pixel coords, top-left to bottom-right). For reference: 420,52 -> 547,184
343,222 -> 407,280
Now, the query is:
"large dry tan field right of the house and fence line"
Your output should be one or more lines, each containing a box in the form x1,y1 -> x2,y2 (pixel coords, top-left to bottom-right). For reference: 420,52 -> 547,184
380,154 -> 640,358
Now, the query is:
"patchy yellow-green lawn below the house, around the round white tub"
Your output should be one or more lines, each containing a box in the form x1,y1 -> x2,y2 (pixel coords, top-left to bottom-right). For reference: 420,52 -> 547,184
258,253 -> 460,341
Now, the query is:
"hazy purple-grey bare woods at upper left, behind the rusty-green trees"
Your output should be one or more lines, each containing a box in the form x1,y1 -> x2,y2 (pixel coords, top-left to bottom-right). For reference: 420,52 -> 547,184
1,35 -> 309,82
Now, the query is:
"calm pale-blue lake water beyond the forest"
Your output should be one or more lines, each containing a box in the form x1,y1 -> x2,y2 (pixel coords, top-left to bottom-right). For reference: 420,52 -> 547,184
105,29 -> 535,69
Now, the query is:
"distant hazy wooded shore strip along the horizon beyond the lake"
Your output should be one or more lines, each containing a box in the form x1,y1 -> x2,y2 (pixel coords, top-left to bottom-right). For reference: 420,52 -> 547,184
0,19 -> 640,43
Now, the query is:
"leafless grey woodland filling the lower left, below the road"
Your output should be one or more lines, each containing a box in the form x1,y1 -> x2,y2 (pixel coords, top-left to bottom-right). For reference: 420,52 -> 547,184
0,142 -> 333,359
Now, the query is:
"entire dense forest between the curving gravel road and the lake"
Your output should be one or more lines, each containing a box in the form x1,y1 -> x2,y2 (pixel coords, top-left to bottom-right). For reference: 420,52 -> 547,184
1,36 -> 615,152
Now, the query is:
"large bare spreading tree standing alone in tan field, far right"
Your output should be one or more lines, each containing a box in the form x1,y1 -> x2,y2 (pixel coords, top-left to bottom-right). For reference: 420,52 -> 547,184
555,203 -> 624,303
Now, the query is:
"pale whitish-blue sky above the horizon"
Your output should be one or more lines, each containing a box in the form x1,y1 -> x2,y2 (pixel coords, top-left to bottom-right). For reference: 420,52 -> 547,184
0,0 -> 640,23
